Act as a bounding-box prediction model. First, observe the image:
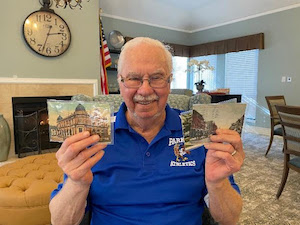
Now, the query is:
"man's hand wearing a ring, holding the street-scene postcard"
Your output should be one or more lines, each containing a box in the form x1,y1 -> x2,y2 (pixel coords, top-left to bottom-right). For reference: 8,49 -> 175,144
204,129 -> 245,185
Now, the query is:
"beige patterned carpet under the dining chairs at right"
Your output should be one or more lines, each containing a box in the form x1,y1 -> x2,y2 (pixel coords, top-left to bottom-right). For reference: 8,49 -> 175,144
235,133 -> 300,225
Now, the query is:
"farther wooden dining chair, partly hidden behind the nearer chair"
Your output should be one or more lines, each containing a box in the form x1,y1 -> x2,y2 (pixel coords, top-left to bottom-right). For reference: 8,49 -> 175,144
265,95 -> 286,156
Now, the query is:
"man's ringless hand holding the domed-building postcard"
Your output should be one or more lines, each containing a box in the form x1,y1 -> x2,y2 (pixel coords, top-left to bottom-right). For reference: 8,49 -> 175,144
56,131 -> 106,186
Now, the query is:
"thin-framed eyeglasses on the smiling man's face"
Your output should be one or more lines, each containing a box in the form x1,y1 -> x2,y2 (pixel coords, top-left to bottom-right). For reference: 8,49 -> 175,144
119,75 -> 172,88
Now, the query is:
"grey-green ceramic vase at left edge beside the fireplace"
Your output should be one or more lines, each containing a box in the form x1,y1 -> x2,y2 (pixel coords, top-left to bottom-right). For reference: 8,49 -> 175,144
0,114 -> 11,162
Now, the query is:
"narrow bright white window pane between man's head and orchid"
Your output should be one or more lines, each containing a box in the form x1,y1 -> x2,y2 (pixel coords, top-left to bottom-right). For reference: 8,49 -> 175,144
171,56 -> 188,89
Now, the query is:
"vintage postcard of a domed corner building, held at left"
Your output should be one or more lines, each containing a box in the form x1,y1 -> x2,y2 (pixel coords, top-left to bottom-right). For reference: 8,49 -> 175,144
47,100 -> 113,144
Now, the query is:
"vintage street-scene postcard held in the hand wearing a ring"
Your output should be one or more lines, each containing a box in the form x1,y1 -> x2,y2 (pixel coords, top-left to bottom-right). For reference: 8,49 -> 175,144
180,103 -> 246,149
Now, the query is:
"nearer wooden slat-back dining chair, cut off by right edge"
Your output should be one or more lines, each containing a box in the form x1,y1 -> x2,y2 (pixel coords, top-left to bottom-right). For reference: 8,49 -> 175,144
276,105 -> 300,199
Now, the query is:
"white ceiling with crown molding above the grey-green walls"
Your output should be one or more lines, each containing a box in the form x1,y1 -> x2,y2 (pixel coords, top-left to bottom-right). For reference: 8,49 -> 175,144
99,0 -> 300,33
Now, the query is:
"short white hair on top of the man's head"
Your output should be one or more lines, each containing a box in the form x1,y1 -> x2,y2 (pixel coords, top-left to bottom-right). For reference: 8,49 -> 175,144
118,37 -> 173,73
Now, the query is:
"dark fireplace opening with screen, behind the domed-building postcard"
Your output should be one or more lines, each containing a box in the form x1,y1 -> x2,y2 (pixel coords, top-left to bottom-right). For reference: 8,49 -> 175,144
12,96 -> 72,157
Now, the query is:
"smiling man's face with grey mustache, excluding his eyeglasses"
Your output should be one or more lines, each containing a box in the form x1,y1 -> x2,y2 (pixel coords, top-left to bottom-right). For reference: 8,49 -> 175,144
119,44 -> 170,120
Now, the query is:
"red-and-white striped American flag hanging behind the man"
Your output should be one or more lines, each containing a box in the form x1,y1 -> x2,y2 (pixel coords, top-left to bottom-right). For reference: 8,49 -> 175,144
99,16 -> 111,95
